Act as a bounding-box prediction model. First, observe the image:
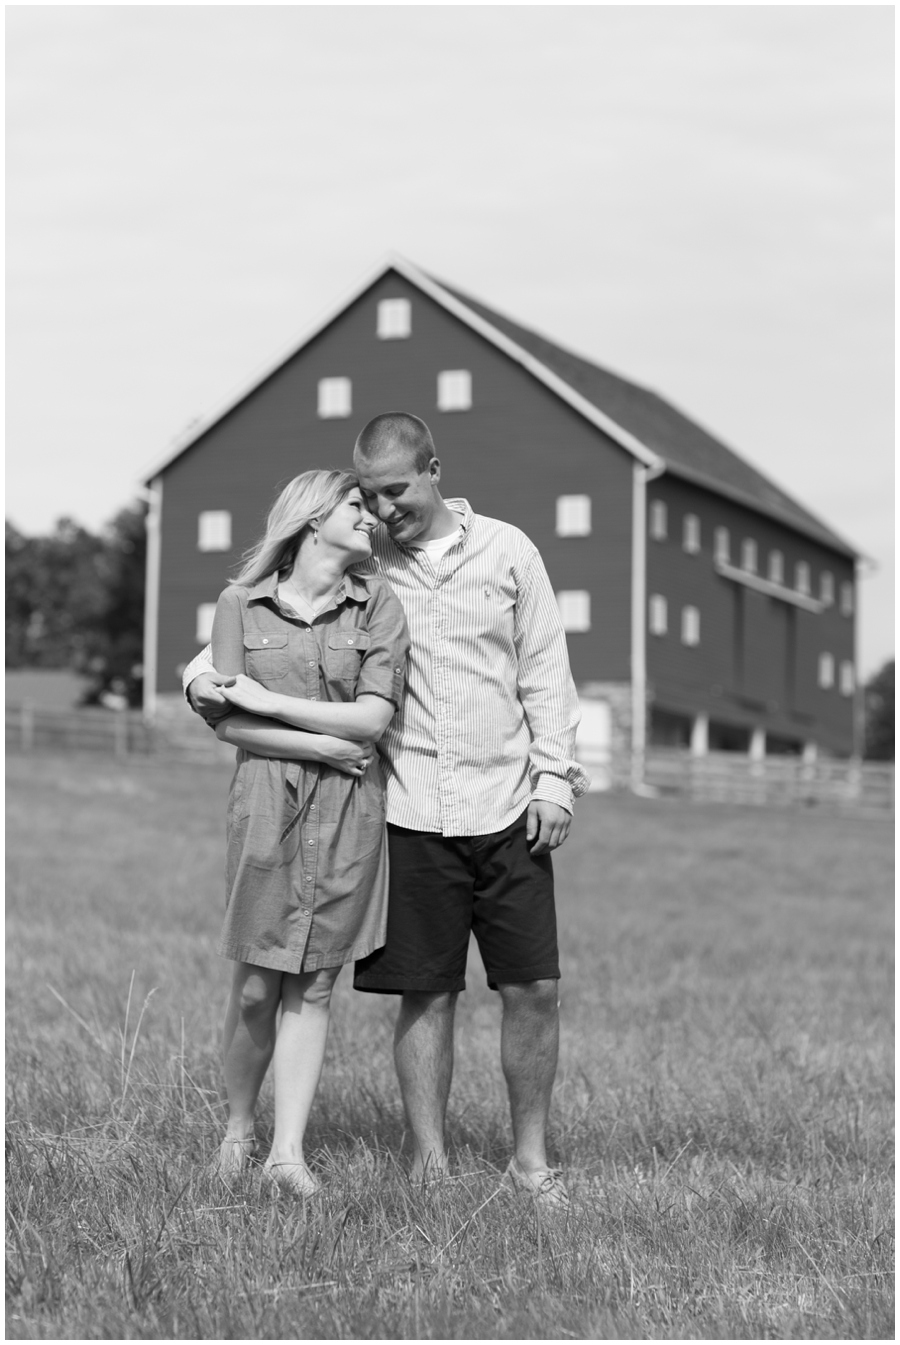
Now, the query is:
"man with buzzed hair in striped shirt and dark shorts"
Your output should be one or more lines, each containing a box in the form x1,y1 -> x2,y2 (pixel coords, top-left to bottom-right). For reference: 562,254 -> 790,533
186,412 -> 588,1209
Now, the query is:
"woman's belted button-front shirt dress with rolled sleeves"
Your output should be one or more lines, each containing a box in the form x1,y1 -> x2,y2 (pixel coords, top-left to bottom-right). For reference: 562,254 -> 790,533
213,572 -> 409,972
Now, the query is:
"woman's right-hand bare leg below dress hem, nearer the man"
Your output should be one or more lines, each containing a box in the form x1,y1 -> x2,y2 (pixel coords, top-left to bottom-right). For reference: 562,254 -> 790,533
265,967 -> 340,1196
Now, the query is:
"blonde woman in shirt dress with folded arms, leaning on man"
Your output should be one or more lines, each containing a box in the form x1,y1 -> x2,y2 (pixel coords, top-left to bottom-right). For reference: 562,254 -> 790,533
213,471 -> 409,1196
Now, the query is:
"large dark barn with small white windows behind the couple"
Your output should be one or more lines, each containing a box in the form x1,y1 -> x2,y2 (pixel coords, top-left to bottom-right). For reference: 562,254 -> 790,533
144,257 -> 860,760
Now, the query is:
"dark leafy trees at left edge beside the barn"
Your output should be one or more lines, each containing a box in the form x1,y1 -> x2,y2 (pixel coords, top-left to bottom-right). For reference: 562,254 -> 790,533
7,504 -> 147,706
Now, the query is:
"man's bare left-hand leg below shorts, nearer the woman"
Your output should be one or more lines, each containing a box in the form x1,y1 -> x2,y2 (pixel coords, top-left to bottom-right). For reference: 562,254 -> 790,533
394,993 -> 457,1181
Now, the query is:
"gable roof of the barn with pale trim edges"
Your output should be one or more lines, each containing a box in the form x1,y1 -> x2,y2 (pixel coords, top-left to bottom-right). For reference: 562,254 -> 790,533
144,254 -> 860,557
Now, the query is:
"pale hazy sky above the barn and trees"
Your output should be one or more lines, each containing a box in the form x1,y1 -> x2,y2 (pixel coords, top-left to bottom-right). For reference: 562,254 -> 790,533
5,5 -> 893,677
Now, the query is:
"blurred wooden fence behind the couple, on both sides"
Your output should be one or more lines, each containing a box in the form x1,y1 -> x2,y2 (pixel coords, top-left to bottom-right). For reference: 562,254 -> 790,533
7,703 -> 895,816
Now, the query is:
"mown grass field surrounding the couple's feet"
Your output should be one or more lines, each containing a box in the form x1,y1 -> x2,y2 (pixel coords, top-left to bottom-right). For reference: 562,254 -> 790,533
7,756 -> 893,1340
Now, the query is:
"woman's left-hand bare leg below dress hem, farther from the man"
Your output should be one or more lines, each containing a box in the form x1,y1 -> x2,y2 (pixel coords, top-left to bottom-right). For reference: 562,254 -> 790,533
217,962 -> 284,1176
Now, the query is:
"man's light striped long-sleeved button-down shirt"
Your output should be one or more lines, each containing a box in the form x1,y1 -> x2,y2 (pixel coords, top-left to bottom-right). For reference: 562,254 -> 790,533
373,499 -> 589,835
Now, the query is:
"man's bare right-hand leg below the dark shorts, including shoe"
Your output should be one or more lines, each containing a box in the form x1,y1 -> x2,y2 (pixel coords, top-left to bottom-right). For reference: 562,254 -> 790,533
498,981 -> 560,1173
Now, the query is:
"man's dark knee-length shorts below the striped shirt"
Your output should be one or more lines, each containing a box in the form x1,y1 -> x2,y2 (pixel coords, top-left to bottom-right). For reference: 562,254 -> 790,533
354,812 -> 560,994
